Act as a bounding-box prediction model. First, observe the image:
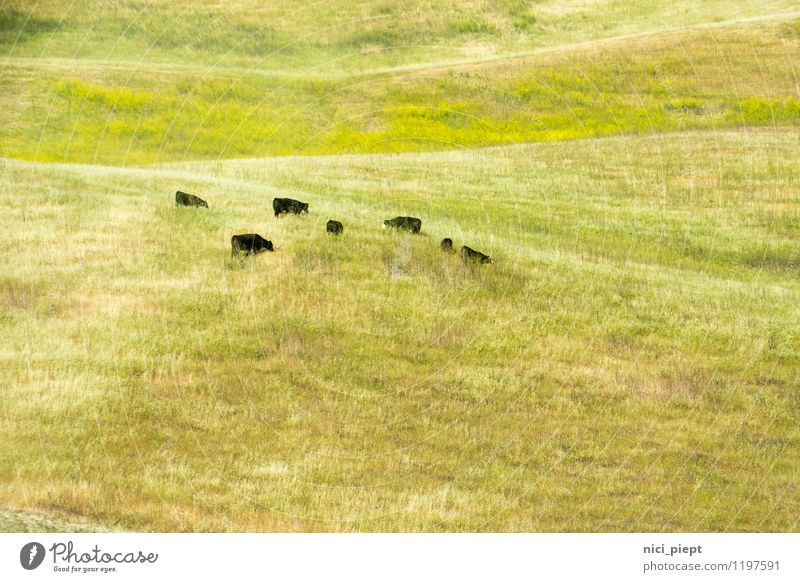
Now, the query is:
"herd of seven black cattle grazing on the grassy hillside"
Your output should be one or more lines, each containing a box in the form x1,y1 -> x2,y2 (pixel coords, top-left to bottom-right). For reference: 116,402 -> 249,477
175,190 -> 492,264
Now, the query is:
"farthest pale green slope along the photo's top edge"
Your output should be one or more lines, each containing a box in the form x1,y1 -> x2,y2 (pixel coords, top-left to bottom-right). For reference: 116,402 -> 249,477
0,0 -> 798,71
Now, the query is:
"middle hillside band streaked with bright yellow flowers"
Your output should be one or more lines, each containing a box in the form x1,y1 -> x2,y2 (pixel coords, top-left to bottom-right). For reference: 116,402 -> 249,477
0,9 -> 800,165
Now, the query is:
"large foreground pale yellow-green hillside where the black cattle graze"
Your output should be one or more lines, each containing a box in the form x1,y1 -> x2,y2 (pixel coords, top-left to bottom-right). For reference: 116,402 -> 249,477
0,132 -> 800,531
